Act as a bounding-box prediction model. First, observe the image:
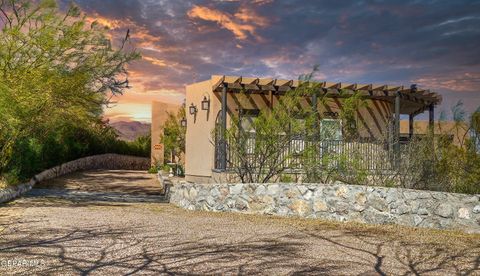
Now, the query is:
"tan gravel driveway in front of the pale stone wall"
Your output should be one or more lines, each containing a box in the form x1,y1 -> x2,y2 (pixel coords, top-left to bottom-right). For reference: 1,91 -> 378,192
0,169 -> 480,275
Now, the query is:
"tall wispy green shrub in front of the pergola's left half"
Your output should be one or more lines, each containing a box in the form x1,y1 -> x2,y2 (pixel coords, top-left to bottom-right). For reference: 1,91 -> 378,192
218,75 -> 318,183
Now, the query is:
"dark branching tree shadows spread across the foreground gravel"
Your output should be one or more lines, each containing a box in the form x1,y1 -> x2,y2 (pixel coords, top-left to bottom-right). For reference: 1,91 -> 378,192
0,216 -> 480,275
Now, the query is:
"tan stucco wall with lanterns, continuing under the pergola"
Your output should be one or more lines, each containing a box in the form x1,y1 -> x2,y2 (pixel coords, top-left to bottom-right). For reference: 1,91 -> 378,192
185,76 -> 393,183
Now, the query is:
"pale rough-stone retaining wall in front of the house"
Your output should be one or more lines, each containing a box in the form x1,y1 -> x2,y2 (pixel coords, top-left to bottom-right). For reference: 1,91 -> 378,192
170,183 -> 480,233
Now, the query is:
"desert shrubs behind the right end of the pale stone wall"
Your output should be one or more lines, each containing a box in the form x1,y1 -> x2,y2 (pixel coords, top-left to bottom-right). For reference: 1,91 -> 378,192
329,116 -> 480,194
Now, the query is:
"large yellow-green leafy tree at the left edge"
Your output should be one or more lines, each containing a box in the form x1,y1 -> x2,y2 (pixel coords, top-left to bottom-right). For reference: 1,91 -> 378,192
0,0 -> 139,183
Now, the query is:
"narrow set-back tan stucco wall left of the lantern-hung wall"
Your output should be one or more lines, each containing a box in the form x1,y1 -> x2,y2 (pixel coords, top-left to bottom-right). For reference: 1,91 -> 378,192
151,101 -> 181,165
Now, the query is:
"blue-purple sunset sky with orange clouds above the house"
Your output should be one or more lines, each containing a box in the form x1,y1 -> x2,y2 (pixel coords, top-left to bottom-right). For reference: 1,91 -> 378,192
64,0 -> 480,122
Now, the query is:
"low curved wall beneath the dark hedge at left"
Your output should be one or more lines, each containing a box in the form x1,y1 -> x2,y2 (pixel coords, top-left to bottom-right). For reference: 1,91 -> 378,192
0,154 -> 150,203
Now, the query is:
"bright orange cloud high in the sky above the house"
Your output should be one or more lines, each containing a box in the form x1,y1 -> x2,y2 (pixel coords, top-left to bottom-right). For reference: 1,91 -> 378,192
187,6 -> 268,40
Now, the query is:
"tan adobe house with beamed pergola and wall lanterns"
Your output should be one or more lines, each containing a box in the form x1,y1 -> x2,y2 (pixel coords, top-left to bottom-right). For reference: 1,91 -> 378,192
185,75 -> 442,183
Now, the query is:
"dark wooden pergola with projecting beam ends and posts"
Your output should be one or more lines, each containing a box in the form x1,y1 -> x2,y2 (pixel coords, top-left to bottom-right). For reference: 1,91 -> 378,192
212,75 -> 442,169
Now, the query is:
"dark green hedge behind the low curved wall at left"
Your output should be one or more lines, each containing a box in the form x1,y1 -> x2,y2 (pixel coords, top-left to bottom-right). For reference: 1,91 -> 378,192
2,123 -> 150,184
